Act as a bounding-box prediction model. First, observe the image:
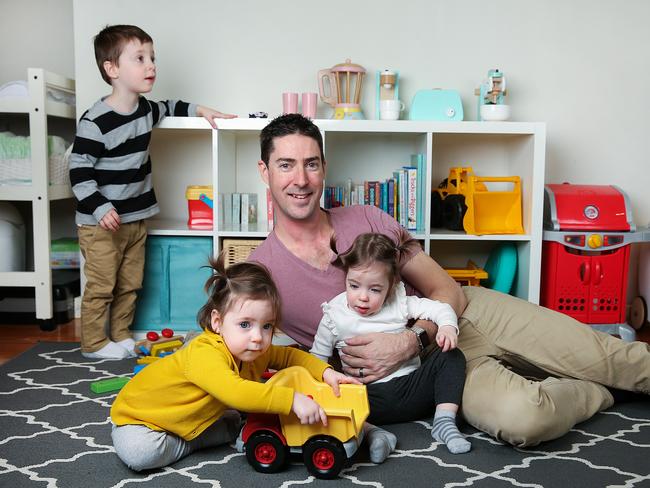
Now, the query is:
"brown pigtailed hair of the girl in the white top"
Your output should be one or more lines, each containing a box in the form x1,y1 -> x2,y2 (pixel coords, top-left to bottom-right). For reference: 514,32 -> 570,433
330,232 -> 419,296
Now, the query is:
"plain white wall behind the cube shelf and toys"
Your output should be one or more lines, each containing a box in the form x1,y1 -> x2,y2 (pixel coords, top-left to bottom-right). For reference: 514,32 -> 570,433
74,0 -> 650,224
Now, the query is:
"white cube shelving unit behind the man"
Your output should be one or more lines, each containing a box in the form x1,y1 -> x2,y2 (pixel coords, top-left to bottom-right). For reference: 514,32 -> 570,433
149,117 -> 546,303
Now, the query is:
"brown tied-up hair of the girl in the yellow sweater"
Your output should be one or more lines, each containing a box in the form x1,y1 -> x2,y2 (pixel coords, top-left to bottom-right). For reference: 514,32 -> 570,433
196,251 -> 282,332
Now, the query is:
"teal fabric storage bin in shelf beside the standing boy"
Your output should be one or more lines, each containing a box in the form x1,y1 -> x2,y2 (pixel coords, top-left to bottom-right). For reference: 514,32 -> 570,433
131,236 -> 212,331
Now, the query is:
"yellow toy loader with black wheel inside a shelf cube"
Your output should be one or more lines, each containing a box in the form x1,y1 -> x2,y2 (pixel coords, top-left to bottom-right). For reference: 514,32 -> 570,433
431,166 -> 524,235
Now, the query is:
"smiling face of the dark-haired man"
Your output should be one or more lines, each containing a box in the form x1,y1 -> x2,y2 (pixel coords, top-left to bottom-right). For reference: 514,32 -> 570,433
258,134 -> 325,224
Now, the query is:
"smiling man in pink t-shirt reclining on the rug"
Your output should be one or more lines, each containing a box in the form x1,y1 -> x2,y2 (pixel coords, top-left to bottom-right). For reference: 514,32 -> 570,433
250,114 -> 650,446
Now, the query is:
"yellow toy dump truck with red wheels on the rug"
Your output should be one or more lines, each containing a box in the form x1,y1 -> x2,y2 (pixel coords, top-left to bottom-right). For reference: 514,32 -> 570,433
242,366 -> 370,479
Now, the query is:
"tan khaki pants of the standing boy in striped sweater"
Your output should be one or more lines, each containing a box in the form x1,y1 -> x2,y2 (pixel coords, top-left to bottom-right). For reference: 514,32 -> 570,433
78,221 -> 147,352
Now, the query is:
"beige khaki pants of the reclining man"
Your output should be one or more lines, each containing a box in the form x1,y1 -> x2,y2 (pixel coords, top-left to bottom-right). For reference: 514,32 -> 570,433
458,287 -> 650,446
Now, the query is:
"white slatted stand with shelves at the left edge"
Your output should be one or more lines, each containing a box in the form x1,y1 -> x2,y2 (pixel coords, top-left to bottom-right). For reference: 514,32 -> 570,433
0,68 -> 76,320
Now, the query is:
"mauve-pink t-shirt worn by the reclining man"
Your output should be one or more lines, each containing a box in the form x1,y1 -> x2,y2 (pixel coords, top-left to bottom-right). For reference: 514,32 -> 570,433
248,205 -> 413,347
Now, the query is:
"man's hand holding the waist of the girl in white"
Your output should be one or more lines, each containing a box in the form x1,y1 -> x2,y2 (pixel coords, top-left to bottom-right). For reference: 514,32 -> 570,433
341,331 -> 419,383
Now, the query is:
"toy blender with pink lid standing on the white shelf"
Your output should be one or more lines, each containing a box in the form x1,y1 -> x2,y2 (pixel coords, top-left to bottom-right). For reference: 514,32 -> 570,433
318,59 -> 366,120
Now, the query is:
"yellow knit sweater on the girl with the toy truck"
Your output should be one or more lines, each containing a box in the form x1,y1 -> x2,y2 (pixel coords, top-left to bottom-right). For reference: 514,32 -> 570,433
111,332 -> 328,441
